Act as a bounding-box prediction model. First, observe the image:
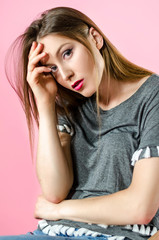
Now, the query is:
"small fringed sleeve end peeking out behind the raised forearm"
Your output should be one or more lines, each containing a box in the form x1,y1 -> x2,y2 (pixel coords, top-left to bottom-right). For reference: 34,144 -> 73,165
57,115 -> 74,136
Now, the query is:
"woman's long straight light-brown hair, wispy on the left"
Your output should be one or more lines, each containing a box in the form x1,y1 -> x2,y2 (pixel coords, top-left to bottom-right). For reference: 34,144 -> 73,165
6,7 -> 153,155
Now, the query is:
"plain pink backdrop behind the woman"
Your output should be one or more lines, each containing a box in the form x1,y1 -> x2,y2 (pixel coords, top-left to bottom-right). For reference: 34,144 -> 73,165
0,0 -> 159,235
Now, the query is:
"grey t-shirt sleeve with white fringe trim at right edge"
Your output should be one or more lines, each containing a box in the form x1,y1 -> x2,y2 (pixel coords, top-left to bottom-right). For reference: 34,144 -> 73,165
131,89 -> 159,166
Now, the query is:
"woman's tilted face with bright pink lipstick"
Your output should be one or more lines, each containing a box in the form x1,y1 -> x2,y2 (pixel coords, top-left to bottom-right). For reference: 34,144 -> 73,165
38,29 -> 104,97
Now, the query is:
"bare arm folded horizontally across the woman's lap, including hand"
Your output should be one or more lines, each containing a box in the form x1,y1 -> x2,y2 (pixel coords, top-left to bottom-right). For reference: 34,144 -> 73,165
35,157 -> 159,225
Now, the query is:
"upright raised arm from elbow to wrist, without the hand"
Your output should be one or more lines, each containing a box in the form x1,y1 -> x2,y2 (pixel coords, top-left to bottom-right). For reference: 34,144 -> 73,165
36,102 -> 73,203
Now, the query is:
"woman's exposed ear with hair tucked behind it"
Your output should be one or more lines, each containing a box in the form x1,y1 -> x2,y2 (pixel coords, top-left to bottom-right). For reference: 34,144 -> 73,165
89,27 -> 103,50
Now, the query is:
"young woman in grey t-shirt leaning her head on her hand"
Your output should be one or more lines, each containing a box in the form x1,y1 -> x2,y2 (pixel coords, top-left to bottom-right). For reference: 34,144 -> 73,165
4,7 -> 159,240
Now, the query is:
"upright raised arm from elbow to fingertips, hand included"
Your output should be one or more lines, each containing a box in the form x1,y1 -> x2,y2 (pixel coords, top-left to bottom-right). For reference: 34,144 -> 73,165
27,40 -> 73,203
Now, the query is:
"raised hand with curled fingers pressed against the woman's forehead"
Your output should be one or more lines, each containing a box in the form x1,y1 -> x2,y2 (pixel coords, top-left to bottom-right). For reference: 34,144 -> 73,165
27,42 -> 57,105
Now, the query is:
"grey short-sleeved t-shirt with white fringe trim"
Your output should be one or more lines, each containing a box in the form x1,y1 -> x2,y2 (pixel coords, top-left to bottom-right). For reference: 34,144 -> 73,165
37,74 -> 159,240
